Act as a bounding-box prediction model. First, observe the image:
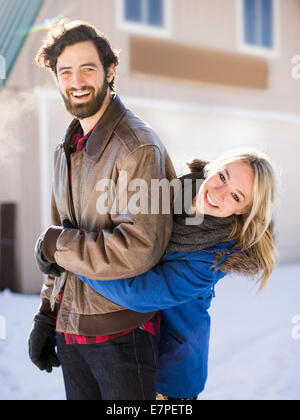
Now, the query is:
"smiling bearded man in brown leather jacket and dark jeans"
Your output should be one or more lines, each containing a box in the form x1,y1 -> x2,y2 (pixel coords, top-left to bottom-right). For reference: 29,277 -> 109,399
29,21 -> 175,400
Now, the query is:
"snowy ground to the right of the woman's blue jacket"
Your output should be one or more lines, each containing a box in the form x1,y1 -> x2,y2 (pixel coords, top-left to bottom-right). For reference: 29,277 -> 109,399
199,265 -> 300,400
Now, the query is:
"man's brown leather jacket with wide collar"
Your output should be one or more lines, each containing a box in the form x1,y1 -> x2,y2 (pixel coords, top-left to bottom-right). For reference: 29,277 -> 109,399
41,96 -> 175,336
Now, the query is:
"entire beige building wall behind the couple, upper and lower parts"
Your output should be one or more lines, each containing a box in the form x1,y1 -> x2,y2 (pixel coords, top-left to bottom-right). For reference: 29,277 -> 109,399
0,0 -> 300,293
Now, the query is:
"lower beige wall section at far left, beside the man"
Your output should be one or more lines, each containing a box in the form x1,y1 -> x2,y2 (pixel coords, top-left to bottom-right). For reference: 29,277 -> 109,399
0,90 -> 40,293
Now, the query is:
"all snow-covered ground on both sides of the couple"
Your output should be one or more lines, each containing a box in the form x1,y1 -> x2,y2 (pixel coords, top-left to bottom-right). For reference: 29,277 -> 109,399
0,265 -> 300,400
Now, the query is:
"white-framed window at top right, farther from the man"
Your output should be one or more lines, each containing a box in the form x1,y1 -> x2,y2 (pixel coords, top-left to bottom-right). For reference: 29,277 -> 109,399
241,0 -> 278,54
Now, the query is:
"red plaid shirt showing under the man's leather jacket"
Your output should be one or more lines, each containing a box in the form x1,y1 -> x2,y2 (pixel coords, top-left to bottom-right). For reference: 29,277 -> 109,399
60,124 -> 161,344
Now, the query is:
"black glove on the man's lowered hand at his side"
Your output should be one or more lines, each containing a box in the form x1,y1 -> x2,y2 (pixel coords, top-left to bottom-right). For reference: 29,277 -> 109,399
28,312 -> 60,373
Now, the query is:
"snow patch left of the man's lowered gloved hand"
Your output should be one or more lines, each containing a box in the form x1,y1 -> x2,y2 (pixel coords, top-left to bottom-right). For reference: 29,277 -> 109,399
0,291 -> 65,400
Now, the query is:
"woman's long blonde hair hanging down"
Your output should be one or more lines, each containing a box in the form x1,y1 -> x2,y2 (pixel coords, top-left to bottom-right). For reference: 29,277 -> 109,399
204,150 -> 277,290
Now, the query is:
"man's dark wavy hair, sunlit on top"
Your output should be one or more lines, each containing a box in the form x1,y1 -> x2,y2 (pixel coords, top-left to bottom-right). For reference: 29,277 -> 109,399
36,19 -> 119,91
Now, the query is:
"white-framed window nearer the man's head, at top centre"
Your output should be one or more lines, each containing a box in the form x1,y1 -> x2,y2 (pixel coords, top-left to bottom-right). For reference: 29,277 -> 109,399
119,0 -> 170,36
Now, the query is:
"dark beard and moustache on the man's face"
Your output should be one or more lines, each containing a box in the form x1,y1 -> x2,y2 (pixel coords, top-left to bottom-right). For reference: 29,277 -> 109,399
61,78 -> 109,120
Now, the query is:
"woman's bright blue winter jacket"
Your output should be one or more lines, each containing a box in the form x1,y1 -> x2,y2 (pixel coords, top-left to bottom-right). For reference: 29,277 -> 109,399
77,241 -> 235,398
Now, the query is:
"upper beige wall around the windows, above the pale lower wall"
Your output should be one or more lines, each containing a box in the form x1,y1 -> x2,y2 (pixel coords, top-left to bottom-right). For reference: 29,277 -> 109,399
8,0 -> 300,113
